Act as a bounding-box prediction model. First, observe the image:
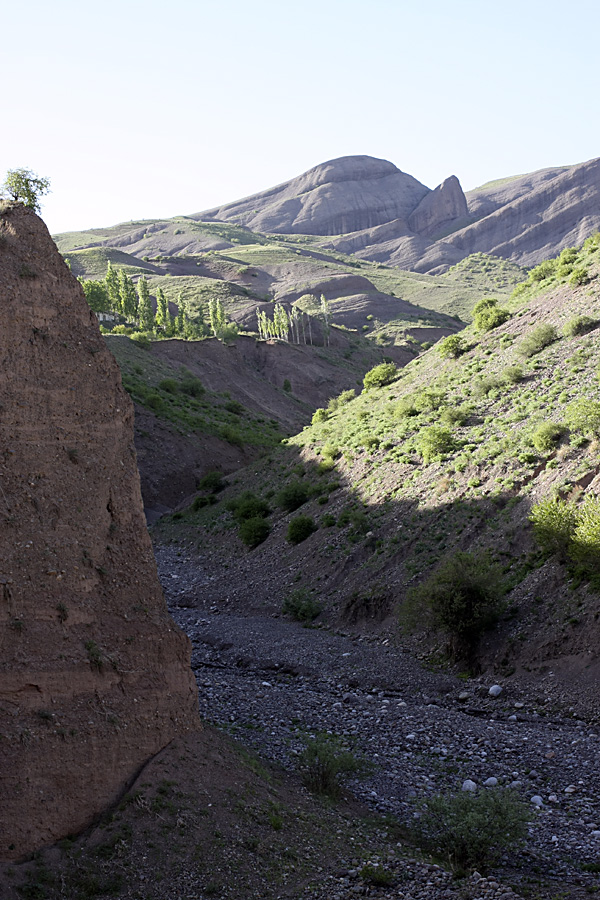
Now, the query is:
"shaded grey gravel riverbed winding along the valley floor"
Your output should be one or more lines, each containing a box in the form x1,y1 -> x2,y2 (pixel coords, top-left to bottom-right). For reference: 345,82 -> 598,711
157,548 -> 600,897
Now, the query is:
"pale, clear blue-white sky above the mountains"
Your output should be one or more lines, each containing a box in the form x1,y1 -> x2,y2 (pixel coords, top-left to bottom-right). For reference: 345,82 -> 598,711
0,0 -> 600,234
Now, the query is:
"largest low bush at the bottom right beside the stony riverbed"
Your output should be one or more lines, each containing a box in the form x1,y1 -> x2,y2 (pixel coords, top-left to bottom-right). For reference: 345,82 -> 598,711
412,787 -> 531,874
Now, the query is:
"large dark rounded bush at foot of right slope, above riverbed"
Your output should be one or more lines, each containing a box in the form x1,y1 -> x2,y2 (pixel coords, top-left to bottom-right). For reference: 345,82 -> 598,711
409,552 -> 504,659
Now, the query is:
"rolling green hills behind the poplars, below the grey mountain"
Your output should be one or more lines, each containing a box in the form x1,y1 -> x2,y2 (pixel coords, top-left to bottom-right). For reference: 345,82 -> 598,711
56,216 -> 525,347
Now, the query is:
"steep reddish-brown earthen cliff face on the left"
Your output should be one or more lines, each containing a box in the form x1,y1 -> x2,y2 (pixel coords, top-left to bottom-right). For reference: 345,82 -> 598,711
0,205 -> 199,859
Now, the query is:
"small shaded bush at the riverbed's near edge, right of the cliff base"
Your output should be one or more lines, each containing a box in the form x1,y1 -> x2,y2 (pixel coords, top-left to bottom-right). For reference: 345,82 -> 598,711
298,734 -> 365,797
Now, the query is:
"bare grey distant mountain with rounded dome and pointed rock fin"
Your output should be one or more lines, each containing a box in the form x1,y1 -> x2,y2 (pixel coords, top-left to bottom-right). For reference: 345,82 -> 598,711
194,156 -> 600,274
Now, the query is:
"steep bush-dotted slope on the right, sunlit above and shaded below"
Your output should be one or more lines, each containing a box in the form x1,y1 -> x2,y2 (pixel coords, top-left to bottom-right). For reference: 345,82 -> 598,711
154,229 -> 600,700
